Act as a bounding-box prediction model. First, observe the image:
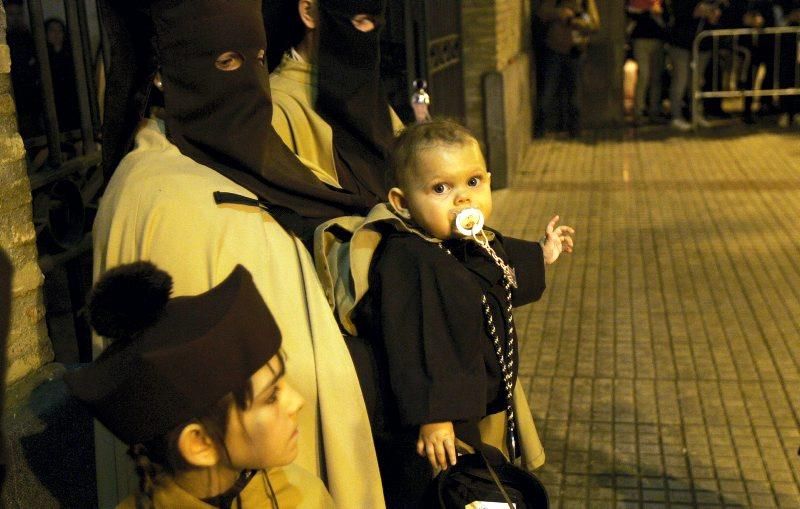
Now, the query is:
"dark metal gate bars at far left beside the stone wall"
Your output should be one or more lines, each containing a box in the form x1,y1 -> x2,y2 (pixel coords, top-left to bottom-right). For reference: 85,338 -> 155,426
12,0 -> 108,361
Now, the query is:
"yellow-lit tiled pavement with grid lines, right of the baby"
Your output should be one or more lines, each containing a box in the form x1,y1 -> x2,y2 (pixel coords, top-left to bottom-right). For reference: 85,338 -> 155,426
492,127 -> 800,508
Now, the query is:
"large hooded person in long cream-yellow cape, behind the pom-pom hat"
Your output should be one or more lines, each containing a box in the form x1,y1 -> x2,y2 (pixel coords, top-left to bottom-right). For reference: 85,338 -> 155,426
93,0 -> 383,507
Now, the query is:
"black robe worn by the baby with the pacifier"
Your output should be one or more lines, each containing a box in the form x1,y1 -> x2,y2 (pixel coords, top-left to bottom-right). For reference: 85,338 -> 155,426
354,232 -> 545,508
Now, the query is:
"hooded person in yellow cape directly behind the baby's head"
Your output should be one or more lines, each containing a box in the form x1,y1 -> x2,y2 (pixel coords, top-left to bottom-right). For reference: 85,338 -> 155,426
264,0 -> 402,205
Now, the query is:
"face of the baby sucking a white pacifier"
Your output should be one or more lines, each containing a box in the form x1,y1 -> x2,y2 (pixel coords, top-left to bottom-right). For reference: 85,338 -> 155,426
389,141 -> 492,240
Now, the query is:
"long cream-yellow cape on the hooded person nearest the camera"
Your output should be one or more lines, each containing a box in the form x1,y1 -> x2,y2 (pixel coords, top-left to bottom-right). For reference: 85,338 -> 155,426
94,120 -> 384,508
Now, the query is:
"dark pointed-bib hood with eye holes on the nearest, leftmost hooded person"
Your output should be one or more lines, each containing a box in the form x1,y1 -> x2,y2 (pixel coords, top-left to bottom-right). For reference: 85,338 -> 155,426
101,0 -> 372,239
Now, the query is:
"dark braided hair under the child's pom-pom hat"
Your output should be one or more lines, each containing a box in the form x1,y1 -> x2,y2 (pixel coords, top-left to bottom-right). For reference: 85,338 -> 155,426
128,355 -> 285,509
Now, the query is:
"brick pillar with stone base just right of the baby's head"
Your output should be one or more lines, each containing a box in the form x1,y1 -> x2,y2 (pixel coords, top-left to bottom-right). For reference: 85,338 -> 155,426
461,0 -> 532,187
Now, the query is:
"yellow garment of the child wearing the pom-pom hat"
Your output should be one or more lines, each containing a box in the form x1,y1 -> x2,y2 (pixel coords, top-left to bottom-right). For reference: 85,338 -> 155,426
117,465 -> 335,509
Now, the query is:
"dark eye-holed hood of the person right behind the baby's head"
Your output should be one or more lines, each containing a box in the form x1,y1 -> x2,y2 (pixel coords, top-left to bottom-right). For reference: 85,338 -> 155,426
316,0 -> 394,208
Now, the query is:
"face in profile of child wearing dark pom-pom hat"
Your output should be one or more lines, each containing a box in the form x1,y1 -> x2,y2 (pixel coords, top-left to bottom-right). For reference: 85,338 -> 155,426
225,355 -> 305,469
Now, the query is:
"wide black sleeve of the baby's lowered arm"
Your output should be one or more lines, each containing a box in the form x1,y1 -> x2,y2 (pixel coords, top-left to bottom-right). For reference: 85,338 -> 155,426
375,236 -> 486,426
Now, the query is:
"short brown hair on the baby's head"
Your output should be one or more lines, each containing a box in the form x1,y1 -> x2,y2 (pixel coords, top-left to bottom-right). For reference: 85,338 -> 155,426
389,118 -> 478,187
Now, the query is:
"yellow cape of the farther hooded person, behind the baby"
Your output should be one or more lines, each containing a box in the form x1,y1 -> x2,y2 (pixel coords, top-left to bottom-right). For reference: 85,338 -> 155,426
269,53 -> 403,187
